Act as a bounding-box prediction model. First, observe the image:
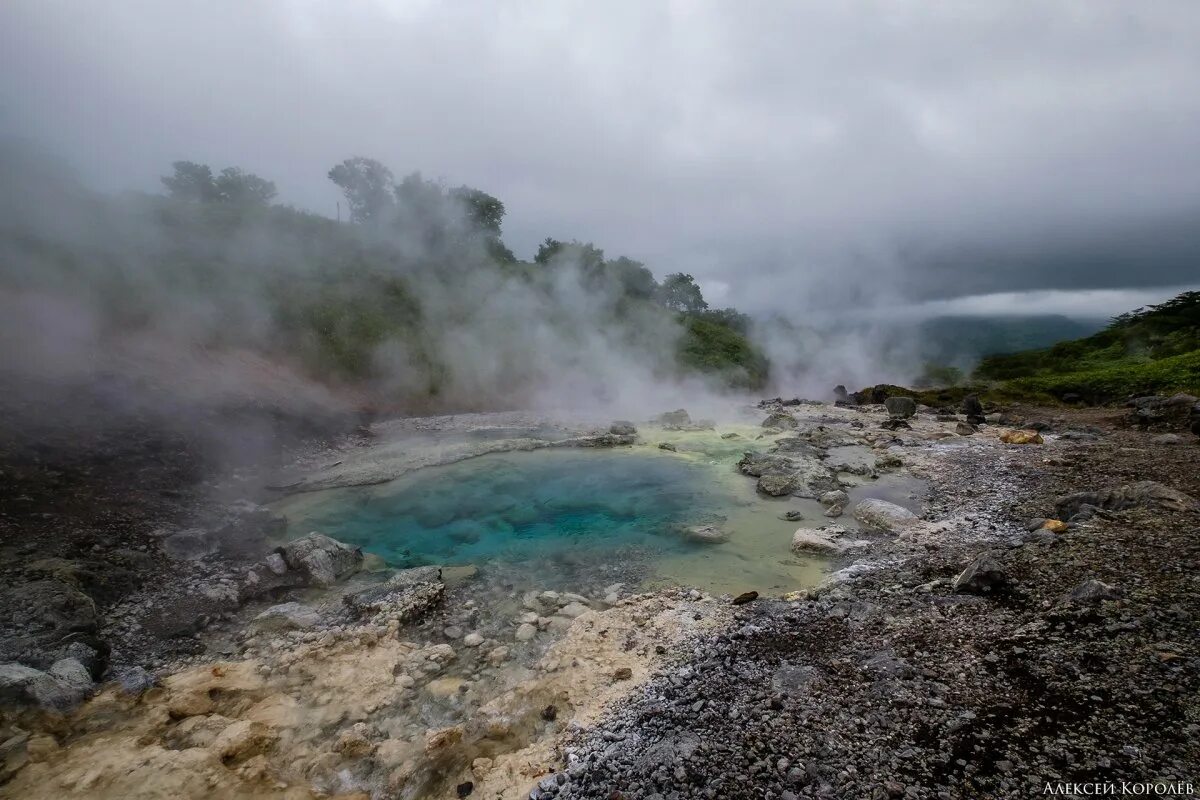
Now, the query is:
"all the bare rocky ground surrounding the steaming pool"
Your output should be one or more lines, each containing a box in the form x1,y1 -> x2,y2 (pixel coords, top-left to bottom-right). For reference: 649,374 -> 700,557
0,386 -> 1200,799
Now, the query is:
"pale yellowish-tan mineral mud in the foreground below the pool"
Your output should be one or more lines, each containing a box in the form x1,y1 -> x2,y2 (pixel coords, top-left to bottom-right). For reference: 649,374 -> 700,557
0,593 -> 728,800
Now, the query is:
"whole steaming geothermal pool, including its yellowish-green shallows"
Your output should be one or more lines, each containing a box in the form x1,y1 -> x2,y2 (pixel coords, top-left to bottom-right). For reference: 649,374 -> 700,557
280,435 -> 926,591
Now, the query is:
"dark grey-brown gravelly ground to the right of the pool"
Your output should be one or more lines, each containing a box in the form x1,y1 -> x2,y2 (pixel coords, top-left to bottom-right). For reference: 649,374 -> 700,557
549,409 -> 1200,800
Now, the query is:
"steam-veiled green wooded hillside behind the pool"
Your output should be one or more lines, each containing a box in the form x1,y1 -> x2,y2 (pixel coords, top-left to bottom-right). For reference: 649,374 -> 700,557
0,149 -> 767,408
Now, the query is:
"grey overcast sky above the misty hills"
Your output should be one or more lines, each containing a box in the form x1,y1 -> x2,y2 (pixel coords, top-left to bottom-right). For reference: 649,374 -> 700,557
0,0 -> 1200,315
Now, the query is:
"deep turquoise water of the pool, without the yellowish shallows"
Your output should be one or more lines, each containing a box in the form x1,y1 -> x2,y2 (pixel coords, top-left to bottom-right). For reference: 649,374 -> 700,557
284,451 -> 736,567
